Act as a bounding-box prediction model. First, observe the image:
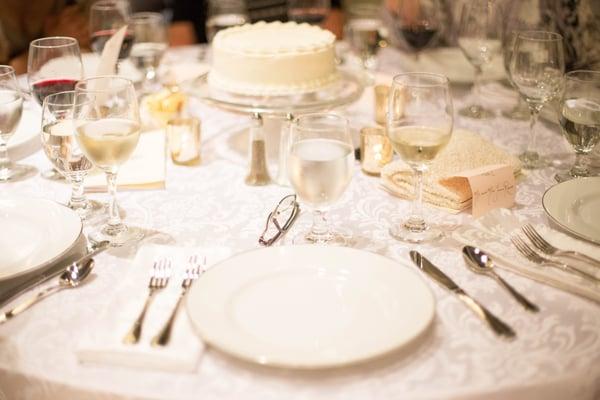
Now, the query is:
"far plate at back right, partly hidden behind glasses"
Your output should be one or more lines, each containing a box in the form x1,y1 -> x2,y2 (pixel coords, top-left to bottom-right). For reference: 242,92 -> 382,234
399,47 -> 506,84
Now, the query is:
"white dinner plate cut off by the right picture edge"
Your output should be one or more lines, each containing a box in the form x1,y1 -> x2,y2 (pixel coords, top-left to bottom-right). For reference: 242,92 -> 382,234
542,177 -> 600,244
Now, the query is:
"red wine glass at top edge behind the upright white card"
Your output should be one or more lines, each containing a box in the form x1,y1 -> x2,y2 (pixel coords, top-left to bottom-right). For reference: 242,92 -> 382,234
90,0 -> 134,60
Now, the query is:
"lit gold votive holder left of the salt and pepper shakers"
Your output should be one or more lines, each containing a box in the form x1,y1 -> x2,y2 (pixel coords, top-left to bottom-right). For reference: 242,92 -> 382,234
167,118 -> 200,166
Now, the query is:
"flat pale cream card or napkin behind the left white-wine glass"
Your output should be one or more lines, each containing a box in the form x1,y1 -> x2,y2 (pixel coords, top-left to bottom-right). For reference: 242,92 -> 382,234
84,130 -> 167,192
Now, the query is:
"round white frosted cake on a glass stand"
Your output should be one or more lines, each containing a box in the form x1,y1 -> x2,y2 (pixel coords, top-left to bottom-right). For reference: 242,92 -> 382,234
208,22 -> 339,96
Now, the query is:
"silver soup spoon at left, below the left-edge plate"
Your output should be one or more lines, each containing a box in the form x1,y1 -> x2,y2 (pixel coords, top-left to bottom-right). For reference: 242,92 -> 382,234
0,259 -> 94,324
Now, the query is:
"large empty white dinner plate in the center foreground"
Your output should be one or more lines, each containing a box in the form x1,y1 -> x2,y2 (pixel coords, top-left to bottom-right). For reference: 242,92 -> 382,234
187,245 -> 435,369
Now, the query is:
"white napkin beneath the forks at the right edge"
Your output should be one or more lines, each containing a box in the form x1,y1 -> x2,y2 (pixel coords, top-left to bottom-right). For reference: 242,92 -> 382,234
452,209 -> 600,302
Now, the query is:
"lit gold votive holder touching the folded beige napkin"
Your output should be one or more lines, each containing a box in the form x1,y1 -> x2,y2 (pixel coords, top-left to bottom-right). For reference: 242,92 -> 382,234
360,126 -> 394,175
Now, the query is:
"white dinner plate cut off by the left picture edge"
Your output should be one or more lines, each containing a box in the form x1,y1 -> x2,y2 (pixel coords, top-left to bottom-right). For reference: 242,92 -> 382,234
0,197 -> 83,281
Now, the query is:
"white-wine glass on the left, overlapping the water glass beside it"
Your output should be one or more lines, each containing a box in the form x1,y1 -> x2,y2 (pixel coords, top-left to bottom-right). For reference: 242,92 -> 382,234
73,76 -> 143,246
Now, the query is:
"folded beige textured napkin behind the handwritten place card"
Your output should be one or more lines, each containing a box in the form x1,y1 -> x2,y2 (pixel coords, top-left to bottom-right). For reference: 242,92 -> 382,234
381,129 -> 521,212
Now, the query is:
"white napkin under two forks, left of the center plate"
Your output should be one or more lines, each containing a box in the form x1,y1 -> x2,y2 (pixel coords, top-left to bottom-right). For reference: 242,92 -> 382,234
76,245 -> 230,372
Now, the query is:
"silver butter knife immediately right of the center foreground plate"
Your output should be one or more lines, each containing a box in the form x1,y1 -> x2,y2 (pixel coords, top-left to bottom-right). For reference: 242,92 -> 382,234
410,250 -> 517,338
